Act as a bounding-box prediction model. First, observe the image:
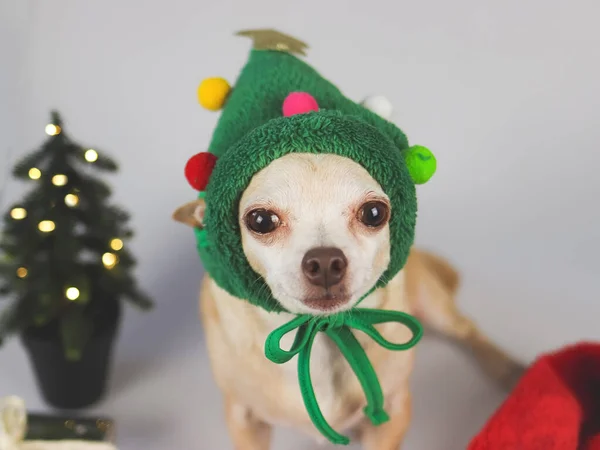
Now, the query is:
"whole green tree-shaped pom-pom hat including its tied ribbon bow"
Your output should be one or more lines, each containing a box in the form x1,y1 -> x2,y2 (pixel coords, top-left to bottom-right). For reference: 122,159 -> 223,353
185,30 -> 436,444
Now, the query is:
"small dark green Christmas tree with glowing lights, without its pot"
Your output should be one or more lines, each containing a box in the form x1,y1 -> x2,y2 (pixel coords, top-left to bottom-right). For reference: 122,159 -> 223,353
0,112 -> 151,360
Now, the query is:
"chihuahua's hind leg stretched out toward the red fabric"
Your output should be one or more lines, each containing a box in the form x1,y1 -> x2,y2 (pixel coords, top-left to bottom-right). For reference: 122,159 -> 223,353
406,252 -> 525,389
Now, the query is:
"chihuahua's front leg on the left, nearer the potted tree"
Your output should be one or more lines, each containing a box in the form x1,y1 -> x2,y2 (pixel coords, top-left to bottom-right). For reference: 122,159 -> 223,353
225,396 -> 271,450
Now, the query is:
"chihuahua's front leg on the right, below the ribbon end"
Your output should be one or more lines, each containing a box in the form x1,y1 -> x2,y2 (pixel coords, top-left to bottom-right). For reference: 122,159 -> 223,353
359,387 -> 411,450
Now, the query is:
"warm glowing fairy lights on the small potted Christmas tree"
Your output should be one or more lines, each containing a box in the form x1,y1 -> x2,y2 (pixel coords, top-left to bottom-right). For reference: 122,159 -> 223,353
10,119 -> 124,301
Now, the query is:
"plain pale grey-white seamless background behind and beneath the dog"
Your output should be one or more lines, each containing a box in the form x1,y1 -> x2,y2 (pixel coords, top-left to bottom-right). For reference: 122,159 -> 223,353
0,0 -> 600,450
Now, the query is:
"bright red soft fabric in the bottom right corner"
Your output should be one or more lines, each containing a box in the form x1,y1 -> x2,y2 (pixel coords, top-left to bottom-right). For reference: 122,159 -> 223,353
467,343 -> 600,450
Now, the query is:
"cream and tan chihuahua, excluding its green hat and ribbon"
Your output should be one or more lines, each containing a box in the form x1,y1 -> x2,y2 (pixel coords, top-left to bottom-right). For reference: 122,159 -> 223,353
173,153 -> 523,450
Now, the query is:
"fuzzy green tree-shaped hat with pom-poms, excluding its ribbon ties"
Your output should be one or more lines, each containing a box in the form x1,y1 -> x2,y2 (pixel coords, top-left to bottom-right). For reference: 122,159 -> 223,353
186,31 -> 436,311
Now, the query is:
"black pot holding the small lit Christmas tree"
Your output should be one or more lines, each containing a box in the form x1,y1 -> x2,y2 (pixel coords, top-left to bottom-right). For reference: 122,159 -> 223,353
21,301 -> 121,409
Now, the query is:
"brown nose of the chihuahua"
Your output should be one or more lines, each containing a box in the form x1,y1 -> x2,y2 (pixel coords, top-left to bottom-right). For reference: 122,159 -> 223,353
302,247 -> 348,289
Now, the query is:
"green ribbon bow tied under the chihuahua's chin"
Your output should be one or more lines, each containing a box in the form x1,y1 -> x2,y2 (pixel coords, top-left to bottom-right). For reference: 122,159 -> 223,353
265,308 -> 423,445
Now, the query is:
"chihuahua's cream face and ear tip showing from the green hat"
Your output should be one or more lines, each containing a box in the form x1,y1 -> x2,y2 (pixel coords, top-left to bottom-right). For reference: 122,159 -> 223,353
174,153 -> 391,314
